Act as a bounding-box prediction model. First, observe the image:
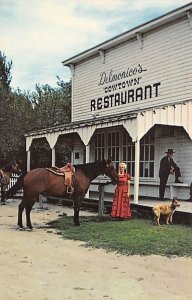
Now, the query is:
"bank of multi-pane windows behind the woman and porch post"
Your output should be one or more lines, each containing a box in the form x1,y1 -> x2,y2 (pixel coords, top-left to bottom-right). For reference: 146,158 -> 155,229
94,129 -> 154,178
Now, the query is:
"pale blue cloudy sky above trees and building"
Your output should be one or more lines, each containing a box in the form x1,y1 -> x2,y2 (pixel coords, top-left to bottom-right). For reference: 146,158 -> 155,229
0,0 -> 190,91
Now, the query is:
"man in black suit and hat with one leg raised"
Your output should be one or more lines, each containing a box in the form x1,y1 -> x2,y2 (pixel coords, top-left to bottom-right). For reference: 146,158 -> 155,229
159,149 -> 182,199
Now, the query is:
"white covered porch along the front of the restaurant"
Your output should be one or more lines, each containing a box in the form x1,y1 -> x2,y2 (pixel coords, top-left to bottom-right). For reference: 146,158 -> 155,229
26,100 -> 192,204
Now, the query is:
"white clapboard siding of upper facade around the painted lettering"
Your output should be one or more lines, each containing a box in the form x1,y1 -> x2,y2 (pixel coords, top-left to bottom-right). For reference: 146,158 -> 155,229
73,18 -> 192,121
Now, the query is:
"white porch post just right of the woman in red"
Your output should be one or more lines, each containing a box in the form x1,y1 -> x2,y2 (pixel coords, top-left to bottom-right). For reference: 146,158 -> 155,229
134,138 -> 140,204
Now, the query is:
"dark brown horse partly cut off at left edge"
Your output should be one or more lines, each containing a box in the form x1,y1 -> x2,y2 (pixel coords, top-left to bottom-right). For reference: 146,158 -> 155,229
0,161 -> 21,205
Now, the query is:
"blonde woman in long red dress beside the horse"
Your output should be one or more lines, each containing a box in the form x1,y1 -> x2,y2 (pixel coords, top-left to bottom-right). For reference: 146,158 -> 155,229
111,162 -> 131,219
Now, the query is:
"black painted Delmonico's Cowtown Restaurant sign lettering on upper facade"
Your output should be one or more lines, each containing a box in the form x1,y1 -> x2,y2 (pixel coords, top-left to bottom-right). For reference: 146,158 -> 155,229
91,64 -> 161,111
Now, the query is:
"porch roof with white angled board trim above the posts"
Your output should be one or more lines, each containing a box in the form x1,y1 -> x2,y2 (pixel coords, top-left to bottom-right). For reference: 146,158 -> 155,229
25,100 -> 192,151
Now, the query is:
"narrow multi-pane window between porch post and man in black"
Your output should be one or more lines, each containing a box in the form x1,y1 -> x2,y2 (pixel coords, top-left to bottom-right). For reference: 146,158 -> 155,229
140,131 -> 154,178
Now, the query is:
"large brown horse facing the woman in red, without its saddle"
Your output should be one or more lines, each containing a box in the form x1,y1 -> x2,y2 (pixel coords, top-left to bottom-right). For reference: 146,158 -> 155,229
13,160 -> 117,229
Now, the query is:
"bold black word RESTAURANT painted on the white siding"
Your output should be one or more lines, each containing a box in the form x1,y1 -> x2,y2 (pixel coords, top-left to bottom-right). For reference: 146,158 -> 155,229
91,82 -> 161,111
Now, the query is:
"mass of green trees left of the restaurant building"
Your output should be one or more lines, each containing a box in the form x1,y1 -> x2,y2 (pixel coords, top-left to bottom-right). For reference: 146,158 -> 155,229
0,51 -> 71,167
